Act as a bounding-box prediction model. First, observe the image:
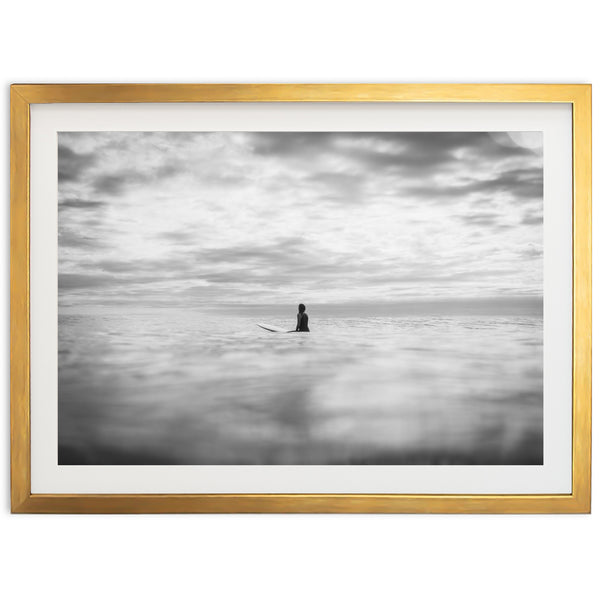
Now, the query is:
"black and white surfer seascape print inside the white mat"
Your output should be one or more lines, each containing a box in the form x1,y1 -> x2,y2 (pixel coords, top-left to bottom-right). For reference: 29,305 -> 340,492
58,131 -> 544,465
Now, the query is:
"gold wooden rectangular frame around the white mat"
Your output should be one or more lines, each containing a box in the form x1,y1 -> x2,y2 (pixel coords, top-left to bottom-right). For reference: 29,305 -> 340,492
10,84 -> 592,513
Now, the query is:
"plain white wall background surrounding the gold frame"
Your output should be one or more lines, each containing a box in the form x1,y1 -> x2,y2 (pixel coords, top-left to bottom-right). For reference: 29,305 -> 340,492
0,0 -> 600,600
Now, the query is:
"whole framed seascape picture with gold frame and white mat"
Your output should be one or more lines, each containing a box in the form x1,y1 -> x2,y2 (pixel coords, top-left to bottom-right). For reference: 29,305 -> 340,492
11,84 -> 591,513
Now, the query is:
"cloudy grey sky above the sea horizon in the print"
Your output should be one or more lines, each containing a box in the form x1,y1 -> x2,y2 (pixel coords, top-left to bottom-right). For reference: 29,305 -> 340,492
58,132 -> 543,308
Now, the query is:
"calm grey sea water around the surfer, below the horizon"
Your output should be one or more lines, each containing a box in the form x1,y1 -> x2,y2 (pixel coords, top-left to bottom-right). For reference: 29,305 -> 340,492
59,310 -> 543,464
